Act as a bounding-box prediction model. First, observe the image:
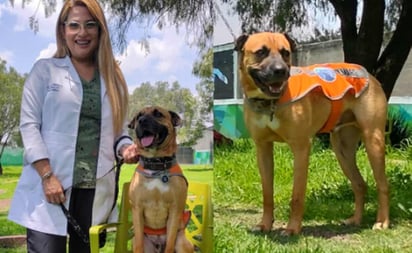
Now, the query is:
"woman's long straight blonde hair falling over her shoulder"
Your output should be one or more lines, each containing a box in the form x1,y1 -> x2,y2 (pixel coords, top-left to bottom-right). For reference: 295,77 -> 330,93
54,0 -> 129,135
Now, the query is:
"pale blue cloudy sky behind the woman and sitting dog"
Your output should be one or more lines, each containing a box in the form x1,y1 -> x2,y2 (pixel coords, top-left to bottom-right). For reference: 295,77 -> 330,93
0,0 -> 200,94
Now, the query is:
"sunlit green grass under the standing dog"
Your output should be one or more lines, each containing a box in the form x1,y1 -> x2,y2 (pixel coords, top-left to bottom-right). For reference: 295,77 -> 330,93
213,140 -> 412,253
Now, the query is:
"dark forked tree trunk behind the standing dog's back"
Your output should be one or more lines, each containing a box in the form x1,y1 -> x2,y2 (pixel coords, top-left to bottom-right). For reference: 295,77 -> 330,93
329,0 -> 412,99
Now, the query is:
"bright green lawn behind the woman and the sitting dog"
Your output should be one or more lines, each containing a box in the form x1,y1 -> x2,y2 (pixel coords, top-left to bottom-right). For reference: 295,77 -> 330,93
0,164 -> 213,253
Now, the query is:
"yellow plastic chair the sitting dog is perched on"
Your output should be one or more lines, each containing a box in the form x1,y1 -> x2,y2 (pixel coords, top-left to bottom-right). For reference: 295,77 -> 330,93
89,182 -> 213,253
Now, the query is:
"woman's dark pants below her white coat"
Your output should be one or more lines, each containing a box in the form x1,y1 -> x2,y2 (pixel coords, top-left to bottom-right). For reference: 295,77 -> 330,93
27,188 -> 95,253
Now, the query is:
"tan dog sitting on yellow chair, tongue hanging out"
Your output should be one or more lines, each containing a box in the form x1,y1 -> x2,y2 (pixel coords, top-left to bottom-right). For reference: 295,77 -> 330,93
129,106 -> 194,253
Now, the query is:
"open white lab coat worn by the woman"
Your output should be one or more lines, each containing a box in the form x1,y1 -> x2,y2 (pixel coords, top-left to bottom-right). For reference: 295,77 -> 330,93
8,57 -> 132,235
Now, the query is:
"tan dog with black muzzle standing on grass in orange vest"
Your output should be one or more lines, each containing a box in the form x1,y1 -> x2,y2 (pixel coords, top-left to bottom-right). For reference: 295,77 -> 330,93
235,33 -> 389,235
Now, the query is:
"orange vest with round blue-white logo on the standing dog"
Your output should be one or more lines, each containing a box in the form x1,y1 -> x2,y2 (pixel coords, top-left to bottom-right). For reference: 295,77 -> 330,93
276,63 -> 369,133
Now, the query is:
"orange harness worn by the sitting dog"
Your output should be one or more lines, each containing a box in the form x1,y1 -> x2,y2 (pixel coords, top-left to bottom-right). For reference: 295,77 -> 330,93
136,163 -> 192,235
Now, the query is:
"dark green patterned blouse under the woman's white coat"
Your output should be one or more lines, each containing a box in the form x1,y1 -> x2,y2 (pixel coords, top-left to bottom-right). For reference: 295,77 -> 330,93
73,71 -> 101,189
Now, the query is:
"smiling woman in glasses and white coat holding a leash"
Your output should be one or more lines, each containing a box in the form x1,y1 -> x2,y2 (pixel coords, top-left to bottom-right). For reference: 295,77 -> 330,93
9,0 -> 137,253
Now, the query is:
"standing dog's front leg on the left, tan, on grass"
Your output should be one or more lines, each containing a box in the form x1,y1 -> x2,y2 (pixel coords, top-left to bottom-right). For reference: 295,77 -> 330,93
253,142 -> 274,232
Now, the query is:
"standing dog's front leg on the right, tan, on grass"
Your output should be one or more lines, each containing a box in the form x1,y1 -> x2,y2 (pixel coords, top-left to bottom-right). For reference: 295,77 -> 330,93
282,139 -> 310,235
